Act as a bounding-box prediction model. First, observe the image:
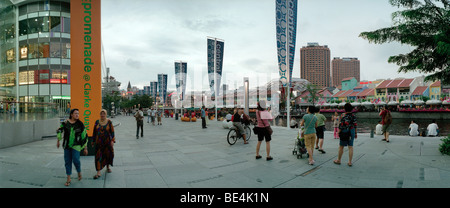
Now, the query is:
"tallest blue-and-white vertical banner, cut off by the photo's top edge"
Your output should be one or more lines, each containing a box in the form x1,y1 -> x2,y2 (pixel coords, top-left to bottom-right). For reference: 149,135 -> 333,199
276,0 -> 297,87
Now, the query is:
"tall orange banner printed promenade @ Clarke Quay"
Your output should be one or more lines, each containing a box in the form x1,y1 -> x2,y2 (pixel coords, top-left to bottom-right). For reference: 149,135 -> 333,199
70,0 -> 102,136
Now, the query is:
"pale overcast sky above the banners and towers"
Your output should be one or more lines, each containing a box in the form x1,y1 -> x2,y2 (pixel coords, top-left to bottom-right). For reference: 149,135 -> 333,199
102,0 -> 428,91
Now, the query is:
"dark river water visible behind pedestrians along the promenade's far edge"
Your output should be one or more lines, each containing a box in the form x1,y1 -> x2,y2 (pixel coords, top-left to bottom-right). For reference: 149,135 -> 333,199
271,117 -> 450,136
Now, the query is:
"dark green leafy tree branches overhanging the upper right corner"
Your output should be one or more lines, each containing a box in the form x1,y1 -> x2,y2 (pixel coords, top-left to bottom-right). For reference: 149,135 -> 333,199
359,0 -> 450,84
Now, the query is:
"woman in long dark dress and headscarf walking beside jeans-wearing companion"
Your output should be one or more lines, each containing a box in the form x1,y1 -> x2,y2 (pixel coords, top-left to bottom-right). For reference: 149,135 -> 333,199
92,109 -> 116,179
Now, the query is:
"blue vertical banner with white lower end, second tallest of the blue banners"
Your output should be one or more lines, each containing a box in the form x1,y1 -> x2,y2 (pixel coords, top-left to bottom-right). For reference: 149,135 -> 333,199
208,39 -> 225,96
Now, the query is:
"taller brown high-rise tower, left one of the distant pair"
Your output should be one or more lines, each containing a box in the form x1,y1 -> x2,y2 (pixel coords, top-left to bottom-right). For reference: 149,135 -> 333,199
300,43 -> 331,87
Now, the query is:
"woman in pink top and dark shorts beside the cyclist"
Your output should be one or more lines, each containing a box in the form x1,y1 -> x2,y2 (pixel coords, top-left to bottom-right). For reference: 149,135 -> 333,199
256,100 -> 273,160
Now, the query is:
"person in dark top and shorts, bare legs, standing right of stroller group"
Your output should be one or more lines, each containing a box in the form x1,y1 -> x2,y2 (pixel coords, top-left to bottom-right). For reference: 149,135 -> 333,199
333,103 -> 358,167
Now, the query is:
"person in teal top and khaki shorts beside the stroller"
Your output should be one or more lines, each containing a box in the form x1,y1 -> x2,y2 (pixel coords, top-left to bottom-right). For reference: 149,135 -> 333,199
300,106 -> 317,165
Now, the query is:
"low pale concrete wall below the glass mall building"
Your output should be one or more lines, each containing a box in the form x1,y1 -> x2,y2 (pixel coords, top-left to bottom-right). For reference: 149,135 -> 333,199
0,118 -> 60,149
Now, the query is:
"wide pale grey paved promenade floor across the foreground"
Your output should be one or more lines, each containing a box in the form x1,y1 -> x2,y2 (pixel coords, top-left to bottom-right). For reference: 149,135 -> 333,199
0,116 -> 450,188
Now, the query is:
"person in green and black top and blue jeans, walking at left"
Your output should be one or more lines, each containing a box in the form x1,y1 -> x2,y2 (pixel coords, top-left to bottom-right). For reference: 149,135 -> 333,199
56,109 -> 88,186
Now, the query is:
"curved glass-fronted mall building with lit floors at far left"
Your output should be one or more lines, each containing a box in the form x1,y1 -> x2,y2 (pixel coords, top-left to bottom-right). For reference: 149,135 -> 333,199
0,0 -> 70,113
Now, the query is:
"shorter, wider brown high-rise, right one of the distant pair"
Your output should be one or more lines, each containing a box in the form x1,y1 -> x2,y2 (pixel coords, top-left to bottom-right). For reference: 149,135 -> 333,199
331,57 -> 361,87
